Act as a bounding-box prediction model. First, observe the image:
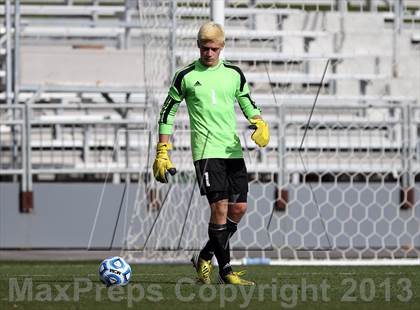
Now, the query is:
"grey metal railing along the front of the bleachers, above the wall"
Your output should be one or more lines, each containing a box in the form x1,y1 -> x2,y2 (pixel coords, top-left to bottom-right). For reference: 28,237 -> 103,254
0,101 -> 420,189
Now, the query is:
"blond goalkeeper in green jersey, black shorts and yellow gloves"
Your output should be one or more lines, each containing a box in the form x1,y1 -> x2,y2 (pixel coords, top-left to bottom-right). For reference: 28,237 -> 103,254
153,22 -> 270,285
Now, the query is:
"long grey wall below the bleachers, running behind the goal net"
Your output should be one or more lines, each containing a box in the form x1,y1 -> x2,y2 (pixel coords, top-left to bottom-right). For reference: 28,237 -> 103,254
0,183 -> 420,248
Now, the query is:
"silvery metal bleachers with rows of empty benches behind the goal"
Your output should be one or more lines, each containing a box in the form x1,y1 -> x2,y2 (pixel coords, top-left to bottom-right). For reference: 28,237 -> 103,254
0,0 -> 420,180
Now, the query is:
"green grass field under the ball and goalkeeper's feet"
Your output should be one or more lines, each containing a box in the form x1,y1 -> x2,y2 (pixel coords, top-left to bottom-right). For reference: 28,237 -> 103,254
0,261 -> 420,310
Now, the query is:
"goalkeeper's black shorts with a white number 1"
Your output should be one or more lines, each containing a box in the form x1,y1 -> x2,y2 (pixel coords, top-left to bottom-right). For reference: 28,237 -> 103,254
194,158 -> 248,204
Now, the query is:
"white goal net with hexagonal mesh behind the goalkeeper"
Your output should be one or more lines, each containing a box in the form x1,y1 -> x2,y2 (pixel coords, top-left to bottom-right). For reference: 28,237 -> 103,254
123,0 -> 420,263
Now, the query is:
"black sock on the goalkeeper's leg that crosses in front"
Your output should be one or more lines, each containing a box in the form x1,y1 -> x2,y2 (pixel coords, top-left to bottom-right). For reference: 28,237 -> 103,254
209,223 -> 232,276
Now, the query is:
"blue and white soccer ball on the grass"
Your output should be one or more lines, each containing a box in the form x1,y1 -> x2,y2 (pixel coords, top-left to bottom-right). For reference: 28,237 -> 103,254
99,256 -> 131,286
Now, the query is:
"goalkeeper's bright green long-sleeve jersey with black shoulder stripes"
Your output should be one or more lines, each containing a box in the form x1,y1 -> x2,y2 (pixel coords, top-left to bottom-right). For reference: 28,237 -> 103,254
159,60 -> 261,161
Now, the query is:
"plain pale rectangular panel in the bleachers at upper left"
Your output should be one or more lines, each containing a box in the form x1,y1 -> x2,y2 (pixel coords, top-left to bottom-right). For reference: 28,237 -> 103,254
21,46 -> 148,87
